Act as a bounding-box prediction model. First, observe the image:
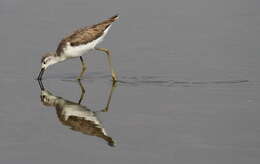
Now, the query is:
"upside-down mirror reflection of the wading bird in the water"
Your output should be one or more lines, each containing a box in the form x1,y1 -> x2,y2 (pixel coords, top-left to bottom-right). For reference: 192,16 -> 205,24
39,81 -> 115,146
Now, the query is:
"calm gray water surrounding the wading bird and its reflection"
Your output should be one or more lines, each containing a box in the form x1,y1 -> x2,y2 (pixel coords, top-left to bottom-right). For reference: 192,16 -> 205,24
0,0 -> 260,164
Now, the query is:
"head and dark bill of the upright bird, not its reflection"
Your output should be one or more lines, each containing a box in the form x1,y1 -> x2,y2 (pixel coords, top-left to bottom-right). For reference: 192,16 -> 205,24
38,53 -> 59,80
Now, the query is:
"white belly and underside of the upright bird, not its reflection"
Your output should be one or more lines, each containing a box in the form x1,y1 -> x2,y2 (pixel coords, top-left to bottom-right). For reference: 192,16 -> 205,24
64,25 -> 111,58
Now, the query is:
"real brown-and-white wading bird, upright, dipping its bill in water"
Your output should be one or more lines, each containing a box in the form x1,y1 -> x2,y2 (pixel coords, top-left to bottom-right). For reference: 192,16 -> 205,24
38,15 -> 119,82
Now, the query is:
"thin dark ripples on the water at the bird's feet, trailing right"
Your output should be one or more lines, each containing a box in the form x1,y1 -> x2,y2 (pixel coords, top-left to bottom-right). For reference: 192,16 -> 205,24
56,72 -> 252,87
